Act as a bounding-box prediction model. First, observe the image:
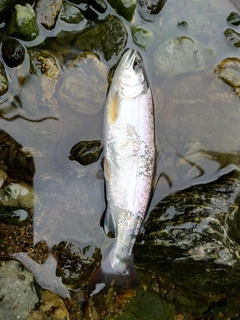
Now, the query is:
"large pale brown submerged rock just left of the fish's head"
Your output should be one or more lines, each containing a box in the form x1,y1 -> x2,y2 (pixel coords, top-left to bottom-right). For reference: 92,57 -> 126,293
58,52 -> 108,114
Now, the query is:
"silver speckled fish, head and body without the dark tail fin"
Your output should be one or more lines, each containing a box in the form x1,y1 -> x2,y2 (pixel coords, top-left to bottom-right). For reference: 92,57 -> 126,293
104,49 -> 156,275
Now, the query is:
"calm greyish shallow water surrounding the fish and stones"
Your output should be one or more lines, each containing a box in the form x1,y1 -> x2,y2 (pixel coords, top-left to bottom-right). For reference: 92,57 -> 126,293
0,0 -> 240,318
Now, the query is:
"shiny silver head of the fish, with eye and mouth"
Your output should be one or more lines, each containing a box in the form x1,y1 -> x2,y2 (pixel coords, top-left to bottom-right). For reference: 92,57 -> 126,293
116,49 -> 149,99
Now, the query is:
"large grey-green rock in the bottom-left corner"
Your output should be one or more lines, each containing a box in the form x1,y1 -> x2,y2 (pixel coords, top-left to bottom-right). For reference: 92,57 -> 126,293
0,260 -> 39,320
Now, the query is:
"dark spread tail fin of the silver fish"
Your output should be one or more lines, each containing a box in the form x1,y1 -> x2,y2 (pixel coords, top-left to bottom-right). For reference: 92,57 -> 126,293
87,258 -> 139,296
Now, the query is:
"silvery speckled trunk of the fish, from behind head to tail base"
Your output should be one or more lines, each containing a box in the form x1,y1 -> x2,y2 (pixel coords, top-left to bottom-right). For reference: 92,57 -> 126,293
105,89 -> 155,273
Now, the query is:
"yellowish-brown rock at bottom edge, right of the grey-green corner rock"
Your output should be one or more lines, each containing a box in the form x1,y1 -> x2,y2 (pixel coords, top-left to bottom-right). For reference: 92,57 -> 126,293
27,290 -> 69,320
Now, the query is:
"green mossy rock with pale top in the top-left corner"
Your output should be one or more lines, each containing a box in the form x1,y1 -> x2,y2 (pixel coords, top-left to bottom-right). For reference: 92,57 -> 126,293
6,3 -> 39,41
